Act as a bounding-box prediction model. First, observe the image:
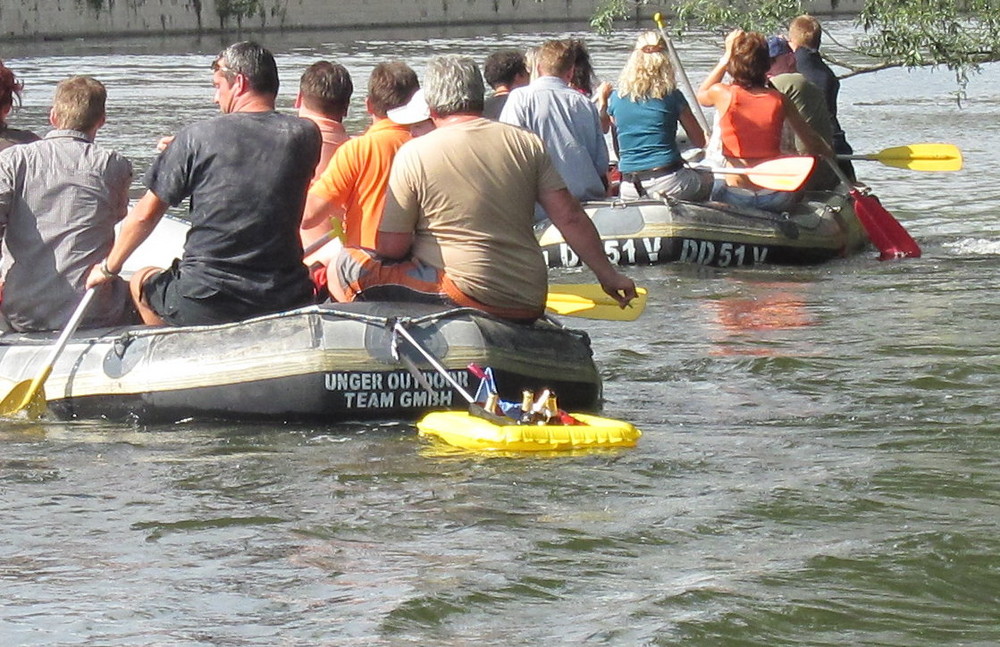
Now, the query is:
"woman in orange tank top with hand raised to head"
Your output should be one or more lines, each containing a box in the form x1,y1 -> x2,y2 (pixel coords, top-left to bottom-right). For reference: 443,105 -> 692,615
698,29 -> 834,212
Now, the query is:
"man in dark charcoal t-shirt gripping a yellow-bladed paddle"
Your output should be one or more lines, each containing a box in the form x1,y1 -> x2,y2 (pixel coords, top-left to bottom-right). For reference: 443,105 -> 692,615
87,41 -> 321,326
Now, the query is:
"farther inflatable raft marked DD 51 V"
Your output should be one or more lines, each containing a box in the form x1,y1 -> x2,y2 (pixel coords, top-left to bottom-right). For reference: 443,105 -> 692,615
538,192 -> 868,267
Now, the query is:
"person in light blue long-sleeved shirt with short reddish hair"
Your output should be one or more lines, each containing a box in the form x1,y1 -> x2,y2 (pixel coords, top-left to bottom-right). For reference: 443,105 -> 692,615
500,41 -> 609,206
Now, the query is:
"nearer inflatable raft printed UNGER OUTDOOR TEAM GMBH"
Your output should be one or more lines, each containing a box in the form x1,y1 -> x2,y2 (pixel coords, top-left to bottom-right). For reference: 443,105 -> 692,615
0,303 -> 601,422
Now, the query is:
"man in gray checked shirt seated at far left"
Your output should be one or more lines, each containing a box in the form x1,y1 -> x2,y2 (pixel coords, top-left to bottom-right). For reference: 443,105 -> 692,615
0,77 -> 137,331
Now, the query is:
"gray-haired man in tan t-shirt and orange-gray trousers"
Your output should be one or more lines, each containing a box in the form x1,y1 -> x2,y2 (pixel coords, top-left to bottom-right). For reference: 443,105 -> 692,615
329,56 -> 635,320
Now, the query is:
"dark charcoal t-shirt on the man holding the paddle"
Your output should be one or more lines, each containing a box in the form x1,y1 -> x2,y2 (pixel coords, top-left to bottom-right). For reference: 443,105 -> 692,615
146,112 -> 319,302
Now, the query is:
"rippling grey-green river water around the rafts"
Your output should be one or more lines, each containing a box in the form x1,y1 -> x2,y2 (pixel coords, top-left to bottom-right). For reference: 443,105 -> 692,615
0,23 -> 1000,647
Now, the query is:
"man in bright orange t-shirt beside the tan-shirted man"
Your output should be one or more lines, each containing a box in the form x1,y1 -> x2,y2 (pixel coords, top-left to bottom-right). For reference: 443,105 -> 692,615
301,61 -> 420,264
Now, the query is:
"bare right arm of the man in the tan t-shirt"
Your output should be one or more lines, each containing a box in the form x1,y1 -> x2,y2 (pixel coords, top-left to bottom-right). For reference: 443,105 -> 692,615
538,189 -> 636,308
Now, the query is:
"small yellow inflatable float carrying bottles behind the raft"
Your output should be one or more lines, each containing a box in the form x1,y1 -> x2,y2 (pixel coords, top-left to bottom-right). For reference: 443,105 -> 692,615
417,411 -> 642,452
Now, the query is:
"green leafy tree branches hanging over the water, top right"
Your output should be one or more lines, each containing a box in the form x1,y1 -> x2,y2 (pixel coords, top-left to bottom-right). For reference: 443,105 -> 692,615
591,0 -> 1000,87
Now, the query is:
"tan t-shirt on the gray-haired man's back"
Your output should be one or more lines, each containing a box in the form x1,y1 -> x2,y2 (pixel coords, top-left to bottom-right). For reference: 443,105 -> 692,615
393,119 -> 560,309
